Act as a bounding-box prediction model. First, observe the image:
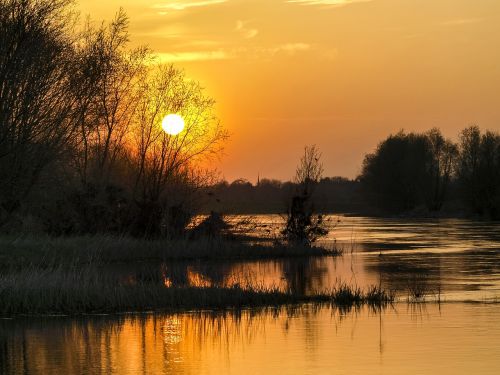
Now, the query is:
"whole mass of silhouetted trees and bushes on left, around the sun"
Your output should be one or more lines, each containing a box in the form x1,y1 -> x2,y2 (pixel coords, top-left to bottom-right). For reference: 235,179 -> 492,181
0,0 -> 227,236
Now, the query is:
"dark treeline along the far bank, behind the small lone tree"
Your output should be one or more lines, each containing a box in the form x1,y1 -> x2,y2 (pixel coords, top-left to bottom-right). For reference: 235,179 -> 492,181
208,126 -> 500,219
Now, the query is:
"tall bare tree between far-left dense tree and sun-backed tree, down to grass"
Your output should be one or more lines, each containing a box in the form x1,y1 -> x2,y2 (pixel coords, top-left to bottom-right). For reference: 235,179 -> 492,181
67,9 -> 149,232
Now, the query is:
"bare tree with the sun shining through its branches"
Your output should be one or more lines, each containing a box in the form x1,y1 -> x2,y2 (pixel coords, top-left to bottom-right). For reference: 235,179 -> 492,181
128,65 -> 228,236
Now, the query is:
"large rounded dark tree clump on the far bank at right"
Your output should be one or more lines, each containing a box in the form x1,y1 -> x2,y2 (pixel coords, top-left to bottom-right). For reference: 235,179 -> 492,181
359,126 -> 500,219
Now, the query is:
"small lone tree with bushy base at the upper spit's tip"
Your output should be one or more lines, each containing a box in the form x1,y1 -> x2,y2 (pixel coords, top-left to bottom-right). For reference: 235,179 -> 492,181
282,146 -> 328,246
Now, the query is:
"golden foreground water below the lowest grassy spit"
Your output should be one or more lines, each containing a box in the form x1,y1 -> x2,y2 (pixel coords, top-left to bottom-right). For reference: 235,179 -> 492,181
0,304 -> 500,374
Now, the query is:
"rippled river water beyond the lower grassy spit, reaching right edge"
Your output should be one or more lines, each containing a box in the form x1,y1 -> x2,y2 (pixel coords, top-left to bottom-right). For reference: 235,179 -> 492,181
102,215 -> 500,301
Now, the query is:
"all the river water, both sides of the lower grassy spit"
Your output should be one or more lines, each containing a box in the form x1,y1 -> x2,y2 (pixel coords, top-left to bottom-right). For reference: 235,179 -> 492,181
0,216 -> 500,374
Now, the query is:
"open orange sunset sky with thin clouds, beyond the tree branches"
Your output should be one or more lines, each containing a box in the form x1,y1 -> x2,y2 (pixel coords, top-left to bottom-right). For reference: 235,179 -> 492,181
78,0 -> 500,181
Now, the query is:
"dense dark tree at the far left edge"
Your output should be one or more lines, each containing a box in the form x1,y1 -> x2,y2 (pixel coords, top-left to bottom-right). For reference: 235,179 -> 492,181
0,0 -> 88,222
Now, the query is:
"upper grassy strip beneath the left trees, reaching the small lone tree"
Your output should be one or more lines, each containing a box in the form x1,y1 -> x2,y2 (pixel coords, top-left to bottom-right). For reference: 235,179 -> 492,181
0,236 -> 341,268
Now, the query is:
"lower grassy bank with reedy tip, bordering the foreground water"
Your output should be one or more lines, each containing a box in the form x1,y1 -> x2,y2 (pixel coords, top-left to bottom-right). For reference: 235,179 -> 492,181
0,266 -> 394,316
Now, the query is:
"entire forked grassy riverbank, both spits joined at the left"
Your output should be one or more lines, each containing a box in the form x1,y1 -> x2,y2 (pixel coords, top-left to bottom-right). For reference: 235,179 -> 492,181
0,236 -> 362,316
